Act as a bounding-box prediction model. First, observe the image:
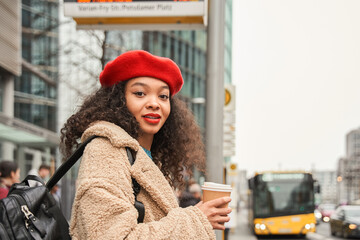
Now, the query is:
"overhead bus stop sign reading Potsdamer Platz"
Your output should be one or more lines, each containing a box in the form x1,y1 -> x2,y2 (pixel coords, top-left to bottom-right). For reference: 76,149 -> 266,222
64,0 -> 208,30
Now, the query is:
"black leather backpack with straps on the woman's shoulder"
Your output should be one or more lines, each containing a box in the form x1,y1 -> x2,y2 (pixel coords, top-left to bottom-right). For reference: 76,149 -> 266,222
0,136 -> 145,240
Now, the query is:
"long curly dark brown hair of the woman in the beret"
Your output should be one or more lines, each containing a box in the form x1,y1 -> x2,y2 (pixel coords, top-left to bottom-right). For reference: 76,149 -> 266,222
60,82 -> 205,187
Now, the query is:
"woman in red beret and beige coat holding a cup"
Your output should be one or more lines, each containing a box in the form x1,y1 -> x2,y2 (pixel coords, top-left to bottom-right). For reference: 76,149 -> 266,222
61,50 -> 231,240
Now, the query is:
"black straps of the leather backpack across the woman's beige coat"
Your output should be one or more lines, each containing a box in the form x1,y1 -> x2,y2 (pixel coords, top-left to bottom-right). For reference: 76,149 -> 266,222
46,135 -> 145,223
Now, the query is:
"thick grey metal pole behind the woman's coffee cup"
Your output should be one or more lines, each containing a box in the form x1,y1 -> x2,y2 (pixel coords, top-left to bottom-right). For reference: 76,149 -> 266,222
205,0 -> 225,239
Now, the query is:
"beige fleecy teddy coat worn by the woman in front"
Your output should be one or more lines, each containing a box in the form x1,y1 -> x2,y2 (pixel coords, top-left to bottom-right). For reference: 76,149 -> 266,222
70,121 -> 215,240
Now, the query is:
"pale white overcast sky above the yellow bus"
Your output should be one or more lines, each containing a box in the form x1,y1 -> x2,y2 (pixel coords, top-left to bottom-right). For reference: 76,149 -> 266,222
233,0 -> 360,175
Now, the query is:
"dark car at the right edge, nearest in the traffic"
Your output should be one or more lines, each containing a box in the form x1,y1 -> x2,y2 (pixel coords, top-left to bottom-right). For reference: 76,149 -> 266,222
330,205 -> 360,238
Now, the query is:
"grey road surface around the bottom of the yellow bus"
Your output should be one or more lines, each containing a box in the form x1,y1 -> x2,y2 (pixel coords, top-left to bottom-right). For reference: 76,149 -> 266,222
229,210 -> 352,240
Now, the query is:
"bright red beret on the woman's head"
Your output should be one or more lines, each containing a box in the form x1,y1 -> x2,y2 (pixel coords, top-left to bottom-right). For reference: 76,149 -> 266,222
100,50 -> 184,96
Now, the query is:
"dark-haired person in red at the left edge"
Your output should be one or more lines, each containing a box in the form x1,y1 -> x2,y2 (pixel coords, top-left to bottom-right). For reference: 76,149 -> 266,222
0,161 -> 20,199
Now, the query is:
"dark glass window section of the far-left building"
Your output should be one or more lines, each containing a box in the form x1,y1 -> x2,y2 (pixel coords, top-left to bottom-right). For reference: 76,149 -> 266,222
15,0 -> 59,132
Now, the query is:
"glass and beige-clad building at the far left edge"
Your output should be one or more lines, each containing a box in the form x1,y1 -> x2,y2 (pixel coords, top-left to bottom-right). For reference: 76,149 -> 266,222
0,0 -> 59,178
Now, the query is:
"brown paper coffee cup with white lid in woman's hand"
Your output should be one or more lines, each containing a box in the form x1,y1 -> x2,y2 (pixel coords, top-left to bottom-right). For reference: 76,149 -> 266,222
201,182 -> 232,207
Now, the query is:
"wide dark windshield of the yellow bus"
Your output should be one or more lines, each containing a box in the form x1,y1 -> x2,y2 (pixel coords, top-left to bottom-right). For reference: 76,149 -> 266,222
254,175 -> 315,218
